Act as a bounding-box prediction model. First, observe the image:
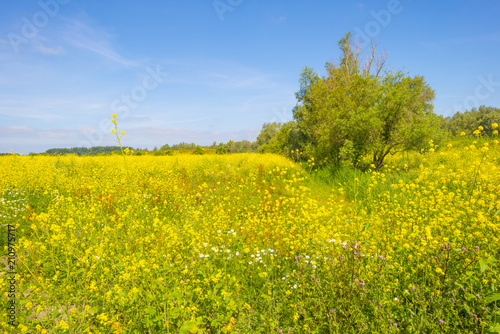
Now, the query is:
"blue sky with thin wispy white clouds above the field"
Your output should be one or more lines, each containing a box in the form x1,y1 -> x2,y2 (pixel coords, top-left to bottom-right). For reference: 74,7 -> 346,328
0,0 -> 500,154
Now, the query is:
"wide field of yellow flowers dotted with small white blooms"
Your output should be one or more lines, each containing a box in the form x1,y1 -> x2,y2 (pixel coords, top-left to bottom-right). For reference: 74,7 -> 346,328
0,138 -> 500,333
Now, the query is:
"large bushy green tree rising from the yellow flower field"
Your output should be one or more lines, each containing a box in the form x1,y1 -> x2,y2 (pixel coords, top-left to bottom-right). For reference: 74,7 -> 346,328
294,34 -> 439,167
